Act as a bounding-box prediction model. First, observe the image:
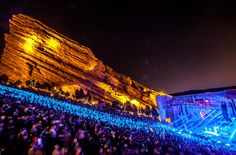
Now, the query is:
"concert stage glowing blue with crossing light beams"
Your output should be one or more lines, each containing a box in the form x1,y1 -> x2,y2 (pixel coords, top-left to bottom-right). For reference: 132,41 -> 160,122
157,89 -> 236,150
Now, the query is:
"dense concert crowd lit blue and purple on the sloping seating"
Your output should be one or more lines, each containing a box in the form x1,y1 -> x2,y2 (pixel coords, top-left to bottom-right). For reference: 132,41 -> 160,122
0,86 -> 233,155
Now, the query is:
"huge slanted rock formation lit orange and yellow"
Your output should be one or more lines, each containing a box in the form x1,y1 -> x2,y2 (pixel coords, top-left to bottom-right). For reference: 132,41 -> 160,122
0,14 -> 168,106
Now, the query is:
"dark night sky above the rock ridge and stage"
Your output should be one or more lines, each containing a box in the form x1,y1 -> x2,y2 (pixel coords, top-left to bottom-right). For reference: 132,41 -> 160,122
0,0 -> 236,93
